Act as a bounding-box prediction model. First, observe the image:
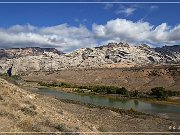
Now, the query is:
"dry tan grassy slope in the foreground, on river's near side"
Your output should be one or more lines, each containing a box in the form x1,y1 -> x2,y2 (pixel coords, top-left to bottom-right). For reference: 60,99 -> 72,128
0,79 -> 179,132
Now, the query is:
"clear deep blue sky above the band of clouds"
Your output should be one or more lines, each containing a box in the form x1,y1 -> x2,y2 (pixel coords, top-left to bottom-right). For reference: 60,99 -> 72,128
0,4 -> 180,28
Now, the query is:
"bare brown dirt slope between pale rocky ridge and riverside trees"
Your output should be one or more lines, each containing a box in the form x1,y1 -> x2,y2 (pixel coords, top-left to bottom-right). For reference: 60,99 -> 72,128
23,66 -> 180,91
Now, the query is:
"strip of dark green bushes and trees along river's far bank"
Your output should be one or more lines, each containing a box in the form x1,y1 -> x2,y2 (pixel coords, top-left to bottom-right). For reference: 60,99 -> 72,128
39,82 -> 180,100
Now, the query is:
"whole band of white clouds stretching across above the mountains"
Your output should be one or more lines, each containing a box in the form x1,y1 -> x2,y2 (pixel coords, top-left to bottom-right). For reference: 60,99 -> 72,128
0,18 -> 180,52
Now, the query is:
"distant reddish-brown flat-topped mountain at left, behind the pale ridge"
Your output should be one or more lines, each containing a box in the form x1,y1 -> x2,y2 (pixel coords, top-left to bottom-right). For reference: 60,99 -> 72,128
0,47 -> 63,59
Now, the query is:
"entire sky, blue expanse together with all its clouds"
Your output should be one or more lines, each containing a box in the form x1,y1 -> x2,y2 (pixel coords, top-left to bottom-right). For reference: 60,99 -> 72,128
0,0 -> 180,52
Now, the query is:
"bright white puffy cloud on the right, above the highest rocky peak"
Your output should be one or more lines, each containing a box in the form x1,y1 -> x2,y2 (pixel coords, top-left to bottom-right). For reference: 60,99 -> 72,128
93,19 -> 180,45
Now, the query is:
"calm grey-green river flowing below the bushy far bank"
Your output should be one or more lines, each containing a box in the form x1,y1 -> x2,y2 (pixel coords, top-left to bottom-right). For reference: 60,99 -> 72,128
36,88 -> 180,121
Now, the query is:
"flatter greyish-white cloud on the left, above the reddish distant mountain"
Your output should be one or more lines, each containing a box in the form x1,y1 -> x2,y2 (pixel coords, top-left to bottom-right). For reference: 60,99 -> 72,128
0,24 -> 96,51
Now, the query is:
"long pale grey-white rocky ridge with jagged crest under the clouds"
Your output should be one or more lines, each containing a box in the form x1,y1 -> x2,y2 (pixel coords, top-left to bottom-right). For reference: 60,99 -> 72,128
0,43 -> 180,74
